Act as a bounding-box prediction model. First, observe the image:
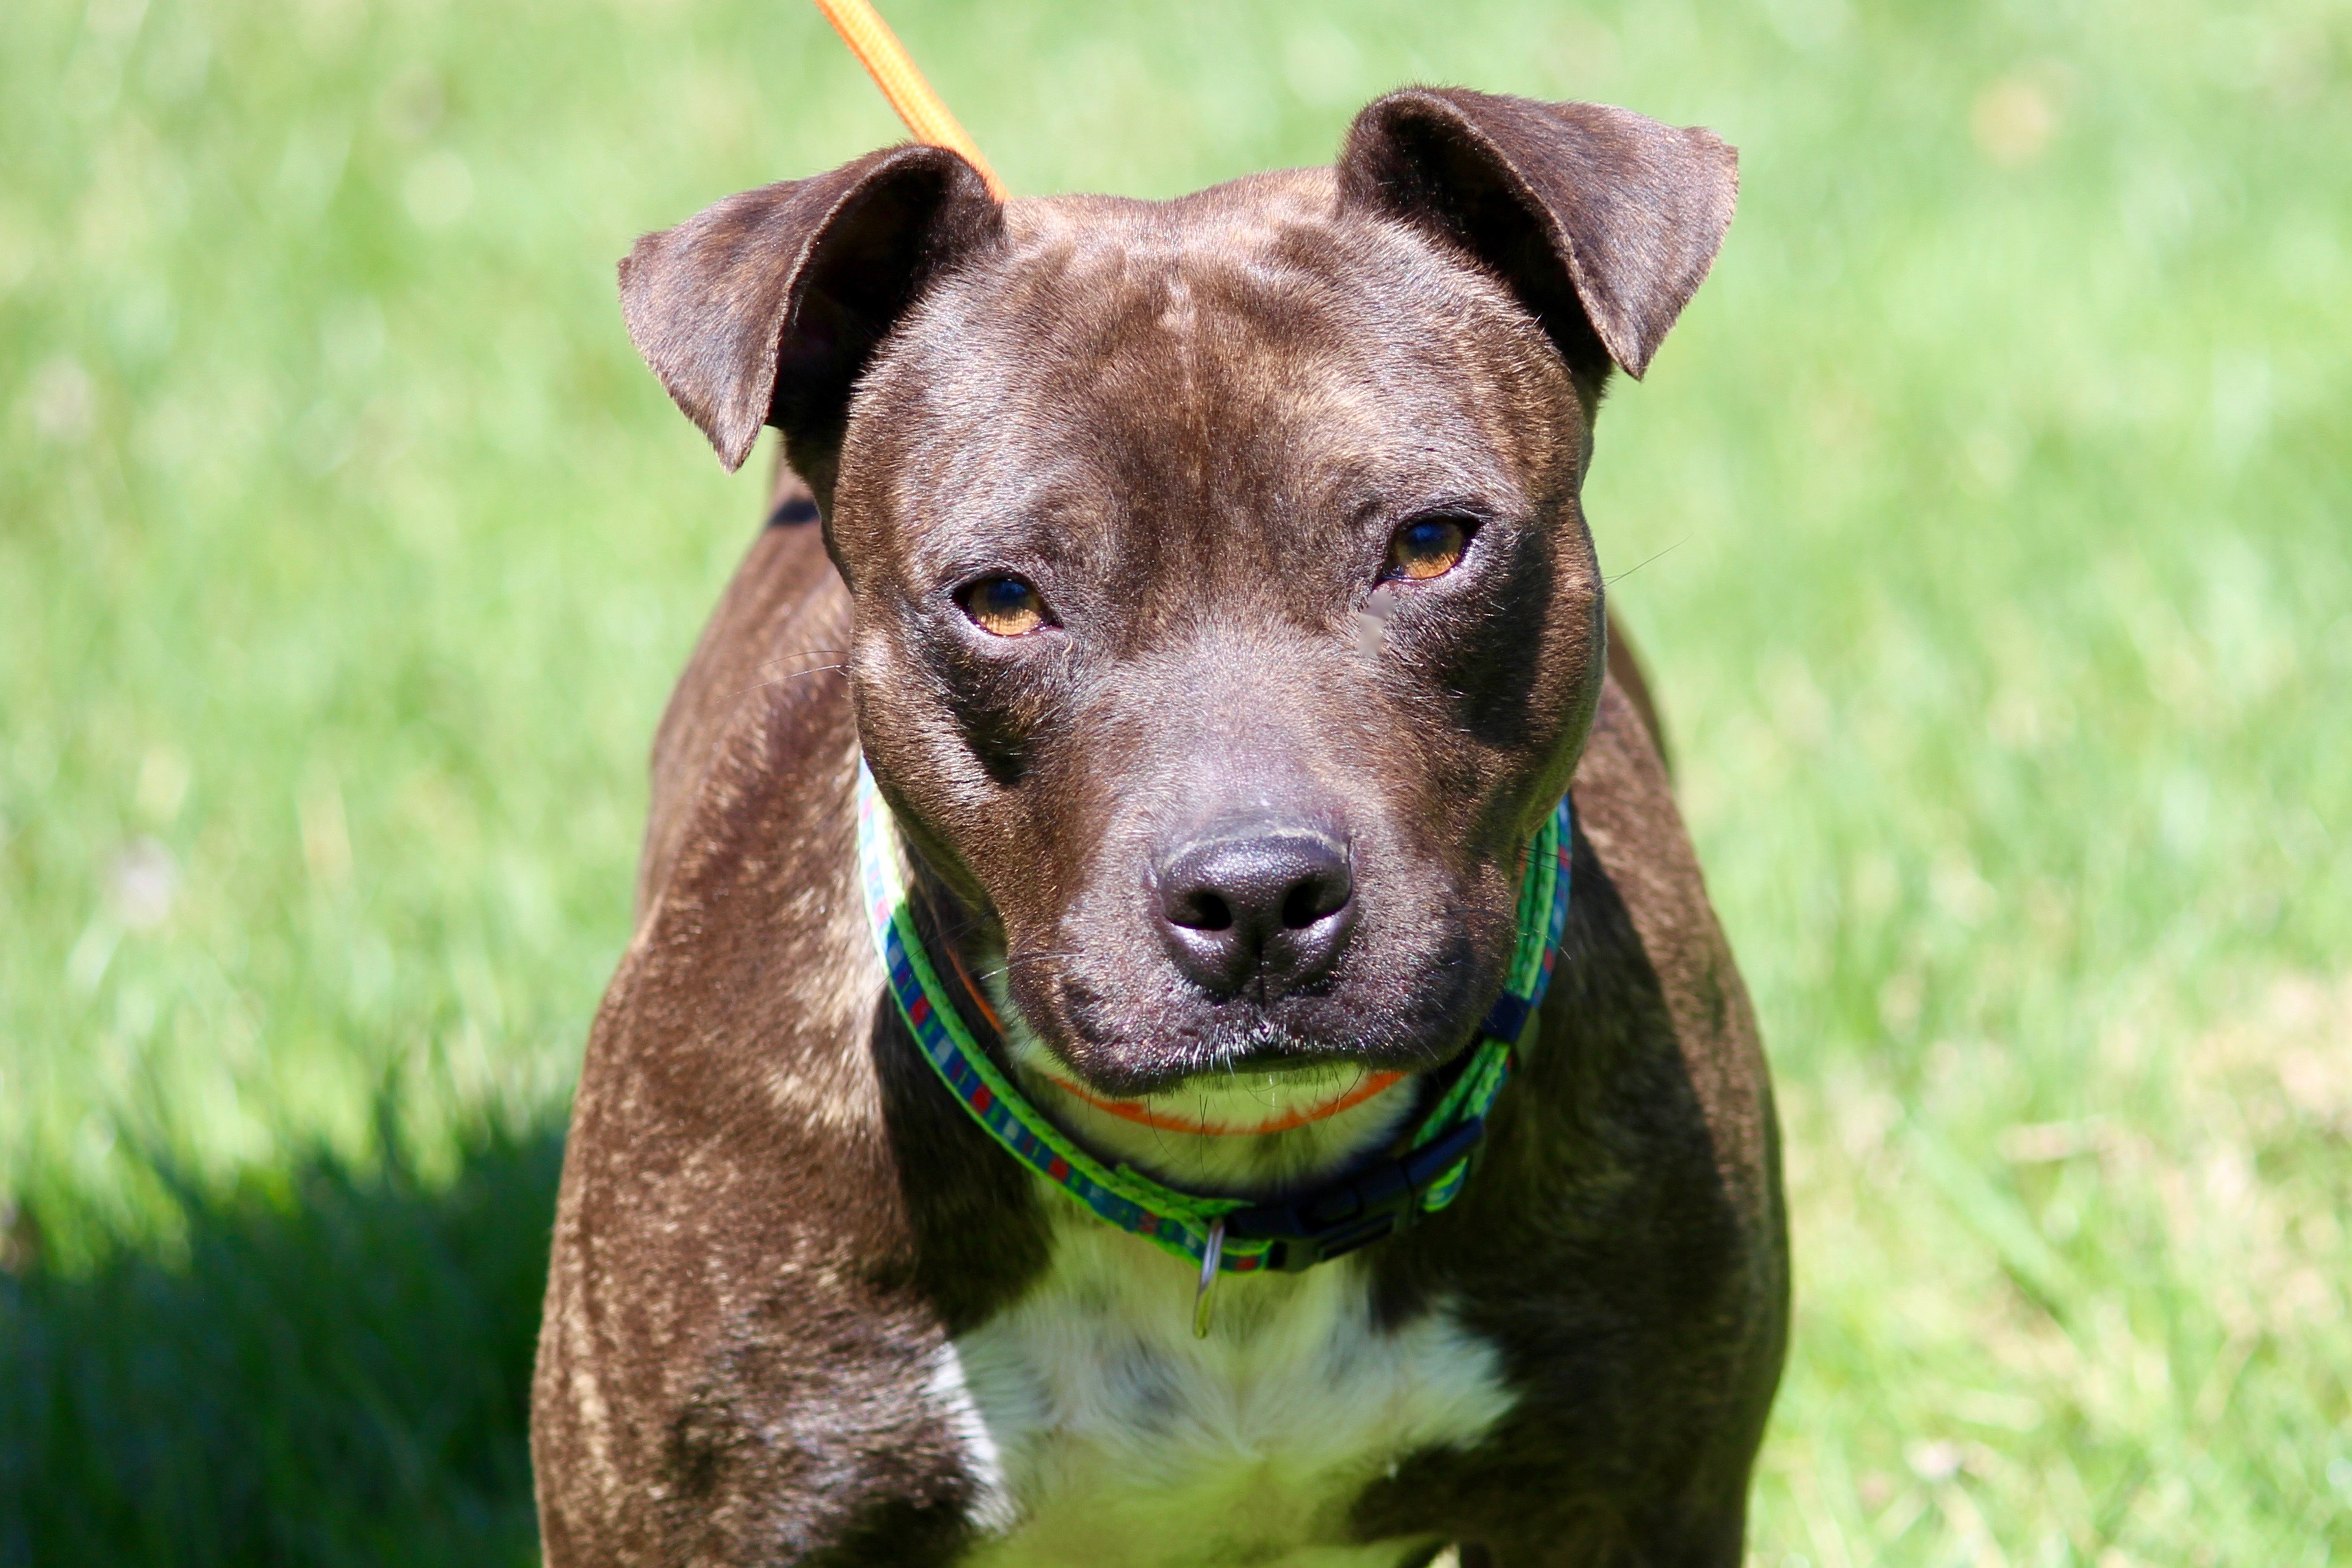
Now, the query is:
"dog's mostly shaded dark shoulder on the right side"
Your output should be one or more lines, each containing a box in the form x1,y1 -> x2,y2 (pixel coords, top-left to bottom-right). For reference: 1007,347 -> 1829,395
1360,680 -> 1788,1561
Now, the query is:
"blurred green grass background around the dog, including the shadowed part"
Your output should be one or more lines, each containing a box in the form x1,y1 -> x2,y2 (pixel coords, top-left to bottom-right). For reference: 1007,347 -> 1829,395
0,0 -> 2352,1568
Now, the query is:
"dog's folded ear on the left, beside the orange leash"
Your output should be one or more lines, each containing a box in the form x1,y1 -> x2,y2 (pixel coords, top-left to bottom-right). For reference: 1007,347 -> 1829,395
621,146 -> 1002,482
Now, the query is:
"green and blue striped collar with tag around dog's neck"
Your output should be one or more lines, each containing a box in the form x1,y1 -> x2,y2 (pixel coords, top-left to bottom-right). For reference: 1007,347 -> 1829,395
858,762 -> 1574,1333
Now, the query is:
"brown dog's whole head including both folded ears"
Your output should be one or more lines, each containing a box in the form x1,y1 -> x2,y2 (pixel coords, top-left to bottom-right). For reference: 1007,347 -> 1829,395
621,91 -> 1736,1114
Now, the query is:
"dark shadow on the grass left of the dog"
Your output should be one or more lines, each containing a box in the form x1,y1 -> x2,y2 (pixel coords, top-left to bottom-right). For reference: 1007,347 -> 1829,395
0,1128 -> 562,1568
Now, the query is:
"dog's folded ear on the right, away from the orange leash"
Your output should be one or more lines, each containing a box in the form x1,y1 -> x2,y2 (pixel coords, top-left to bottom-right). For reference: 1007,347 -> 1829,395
1338,87 -> 1740,398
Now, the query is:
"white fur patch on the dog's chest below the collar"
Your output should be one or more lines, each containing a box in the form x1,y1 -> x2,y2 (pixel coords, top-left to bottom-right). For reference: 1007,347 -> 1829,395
936,1194 -> 1510,1568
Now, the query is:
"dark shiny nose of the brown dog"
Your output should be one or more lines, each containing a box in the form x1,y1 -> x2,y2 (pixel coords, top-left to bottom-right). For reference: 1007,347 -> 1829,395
1157,827 -> 1355,1001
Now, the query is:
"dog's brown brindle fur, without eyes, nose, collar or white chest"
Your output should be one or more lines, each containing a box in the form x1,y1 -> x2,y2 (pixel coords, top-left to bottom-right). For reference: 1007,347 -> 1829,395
534,91 -> 1788,1568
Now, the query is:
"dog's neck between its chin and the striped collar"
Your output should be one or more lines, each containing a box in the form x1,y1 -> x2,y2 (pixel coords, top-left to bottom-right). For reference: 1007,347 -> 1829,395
906,851 -> 1421,1199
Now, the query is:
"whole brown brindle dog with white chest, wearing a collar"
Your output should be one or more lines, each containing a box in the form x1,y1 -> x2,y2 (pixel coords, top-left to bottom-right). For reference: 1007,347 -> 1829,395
531,89 -> 1788,1568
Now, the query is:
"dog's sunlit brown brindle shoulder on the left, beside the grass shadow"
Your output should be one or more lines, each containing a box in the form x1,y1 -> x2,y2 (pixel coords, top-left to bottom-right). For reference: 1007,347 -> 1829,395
534,493 -> 1020,1565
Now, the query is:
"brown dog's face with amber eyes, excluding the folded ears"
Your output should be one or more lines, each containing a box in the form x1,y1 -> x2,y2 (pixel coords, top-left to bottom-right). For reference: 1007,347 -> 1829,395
833,172 -> 1602,1093
